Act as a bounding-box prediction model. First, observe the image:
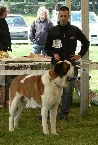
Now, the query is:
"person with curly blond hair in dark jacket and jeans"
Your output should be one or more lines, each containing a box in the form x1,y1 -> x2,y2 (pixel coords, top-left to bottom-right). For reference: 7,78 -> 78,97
29,6 -> 53,56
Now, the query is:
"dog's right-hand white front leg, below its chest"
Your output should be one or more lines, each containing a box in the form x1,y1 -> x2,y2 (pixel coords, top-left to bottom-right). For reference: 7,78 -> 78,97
50,103 -> 58,135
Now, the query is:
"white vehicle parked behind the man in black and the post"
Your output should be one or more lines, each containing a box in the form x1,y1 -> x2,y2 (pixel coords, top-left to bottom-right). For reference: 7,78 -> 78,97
51,10 -> 98,45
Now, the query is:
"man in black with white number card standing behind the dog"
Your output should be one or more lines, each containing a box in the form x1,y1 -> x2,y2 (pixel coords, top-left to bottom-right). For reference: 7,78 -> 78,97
45,6 -> 89,120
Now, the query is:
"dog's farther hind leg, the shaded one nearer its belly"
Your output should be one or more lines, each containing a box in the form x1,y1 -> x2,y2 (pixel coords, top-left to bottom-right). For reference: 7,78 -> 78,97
14,97 -> 27,128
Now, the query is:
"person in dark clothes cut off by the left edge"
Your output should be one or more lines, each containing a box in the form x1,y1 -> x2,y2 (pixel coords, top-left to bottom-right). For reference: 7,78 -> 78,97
0,6 -> 12,86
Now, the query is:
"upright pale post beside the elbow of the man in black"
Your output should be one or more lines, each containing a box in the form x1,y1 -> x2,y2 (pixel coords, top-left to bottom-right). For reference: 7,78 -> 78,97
80,0 -> 89,115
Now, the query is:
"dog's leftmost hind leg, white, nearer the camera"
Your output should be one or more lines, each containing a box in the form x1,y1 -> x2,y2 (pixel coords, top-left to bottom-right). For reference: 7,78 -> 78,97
9,92 -> 22,131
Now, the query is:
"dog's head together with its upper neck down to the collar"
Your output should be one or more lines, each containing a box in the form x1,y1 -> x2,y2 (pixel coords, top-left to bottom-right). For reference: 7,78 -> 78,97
49,60 -> 74,87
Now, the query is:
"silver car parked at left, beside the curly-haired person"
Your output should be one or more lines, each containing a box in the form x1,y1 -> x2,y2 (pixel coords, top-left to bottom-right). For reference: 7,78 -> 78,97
6,14 -> 29,43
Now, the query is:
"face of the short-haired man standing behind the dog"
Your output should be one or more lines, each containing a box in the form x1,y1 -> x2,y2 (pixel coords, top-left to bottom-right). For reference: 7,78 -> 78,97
58,11 -> 70,26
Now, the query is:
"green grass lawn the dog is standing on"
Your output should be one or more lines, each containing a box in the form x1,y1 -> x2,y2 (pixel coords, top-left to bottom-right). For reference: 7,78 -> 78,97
0,97 -> 98,145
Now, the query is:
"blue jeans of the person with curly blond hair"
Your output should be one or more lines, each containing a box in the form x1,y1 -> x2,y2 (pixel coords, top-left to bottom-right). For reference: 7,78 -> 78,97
32,44 -> 48,56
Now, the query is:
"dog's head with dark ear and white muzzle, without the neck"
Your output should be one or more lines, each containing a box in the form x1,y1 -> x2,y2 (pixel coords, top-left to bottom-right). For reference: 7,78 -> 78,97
54,60 -> 74,80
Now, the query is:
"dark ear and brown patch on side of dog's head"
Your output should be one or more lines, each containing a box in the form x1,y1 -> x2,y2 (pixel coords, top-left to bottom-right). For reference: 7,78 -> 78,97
54,62 -> 70,78
